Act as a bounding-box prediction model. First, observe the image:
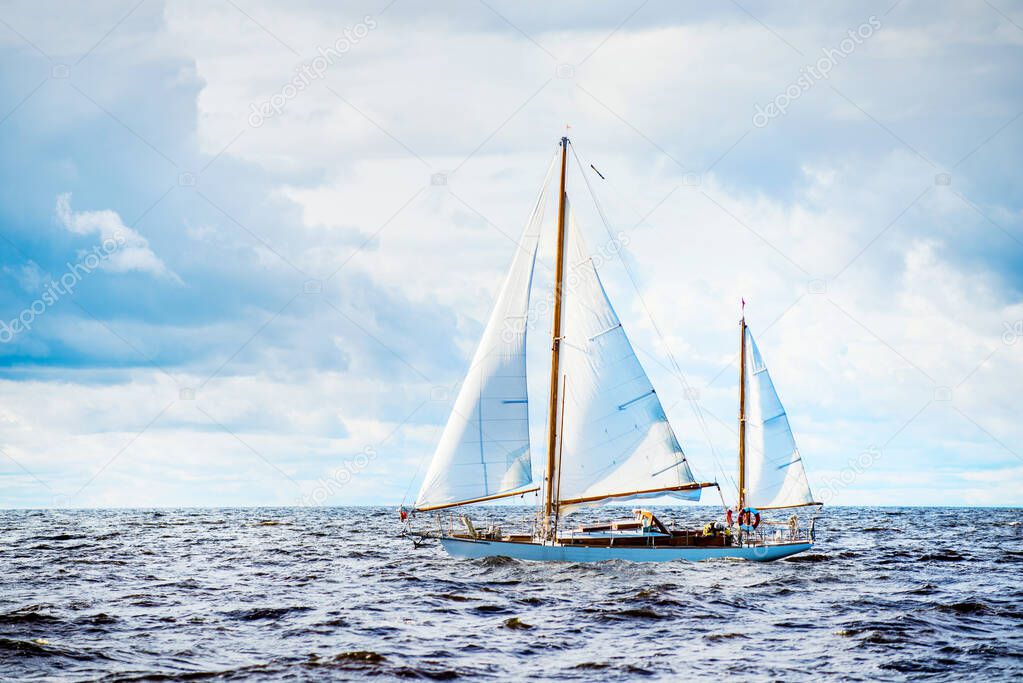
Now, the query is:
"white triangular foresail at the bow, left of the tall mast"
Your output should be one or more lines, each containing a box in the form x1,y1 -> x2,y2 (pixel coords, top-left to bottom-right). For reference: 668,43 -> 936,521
415,164 -> 553,508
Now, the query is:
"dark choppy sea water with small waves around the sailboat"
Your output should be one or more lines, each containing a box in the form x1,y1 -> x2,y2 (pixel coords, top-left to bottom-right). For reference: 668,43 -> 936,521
0,507 -> 1023,681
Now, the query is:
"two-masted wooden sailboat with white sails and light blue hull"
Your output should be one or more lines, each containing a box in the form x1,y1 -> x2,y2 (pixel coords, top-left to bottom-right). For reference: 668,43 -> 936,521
401,137 -> 820,562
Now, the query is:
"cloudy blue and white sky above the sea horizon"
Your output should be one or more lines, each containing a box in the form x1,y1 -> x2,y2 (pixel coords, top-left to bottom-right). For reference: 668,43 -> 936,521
0,0 -> 1023,507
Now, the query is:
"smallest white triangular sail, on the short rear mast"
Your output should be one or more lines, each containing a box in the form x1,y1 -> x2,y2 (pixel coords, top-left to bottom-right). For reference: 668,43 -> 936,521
746,327 -> 813,507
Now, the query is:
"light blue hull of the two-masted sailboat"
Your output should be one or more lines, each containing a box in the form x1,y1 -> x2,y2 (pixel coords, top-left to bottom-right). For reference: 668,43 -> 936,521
440,537 -> 813,562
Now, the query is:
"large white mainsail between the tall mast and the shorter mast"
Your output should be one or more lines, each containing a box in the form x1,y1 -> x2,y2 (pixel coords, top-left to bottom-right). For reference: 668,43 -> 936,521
555,210 -> 701,512
